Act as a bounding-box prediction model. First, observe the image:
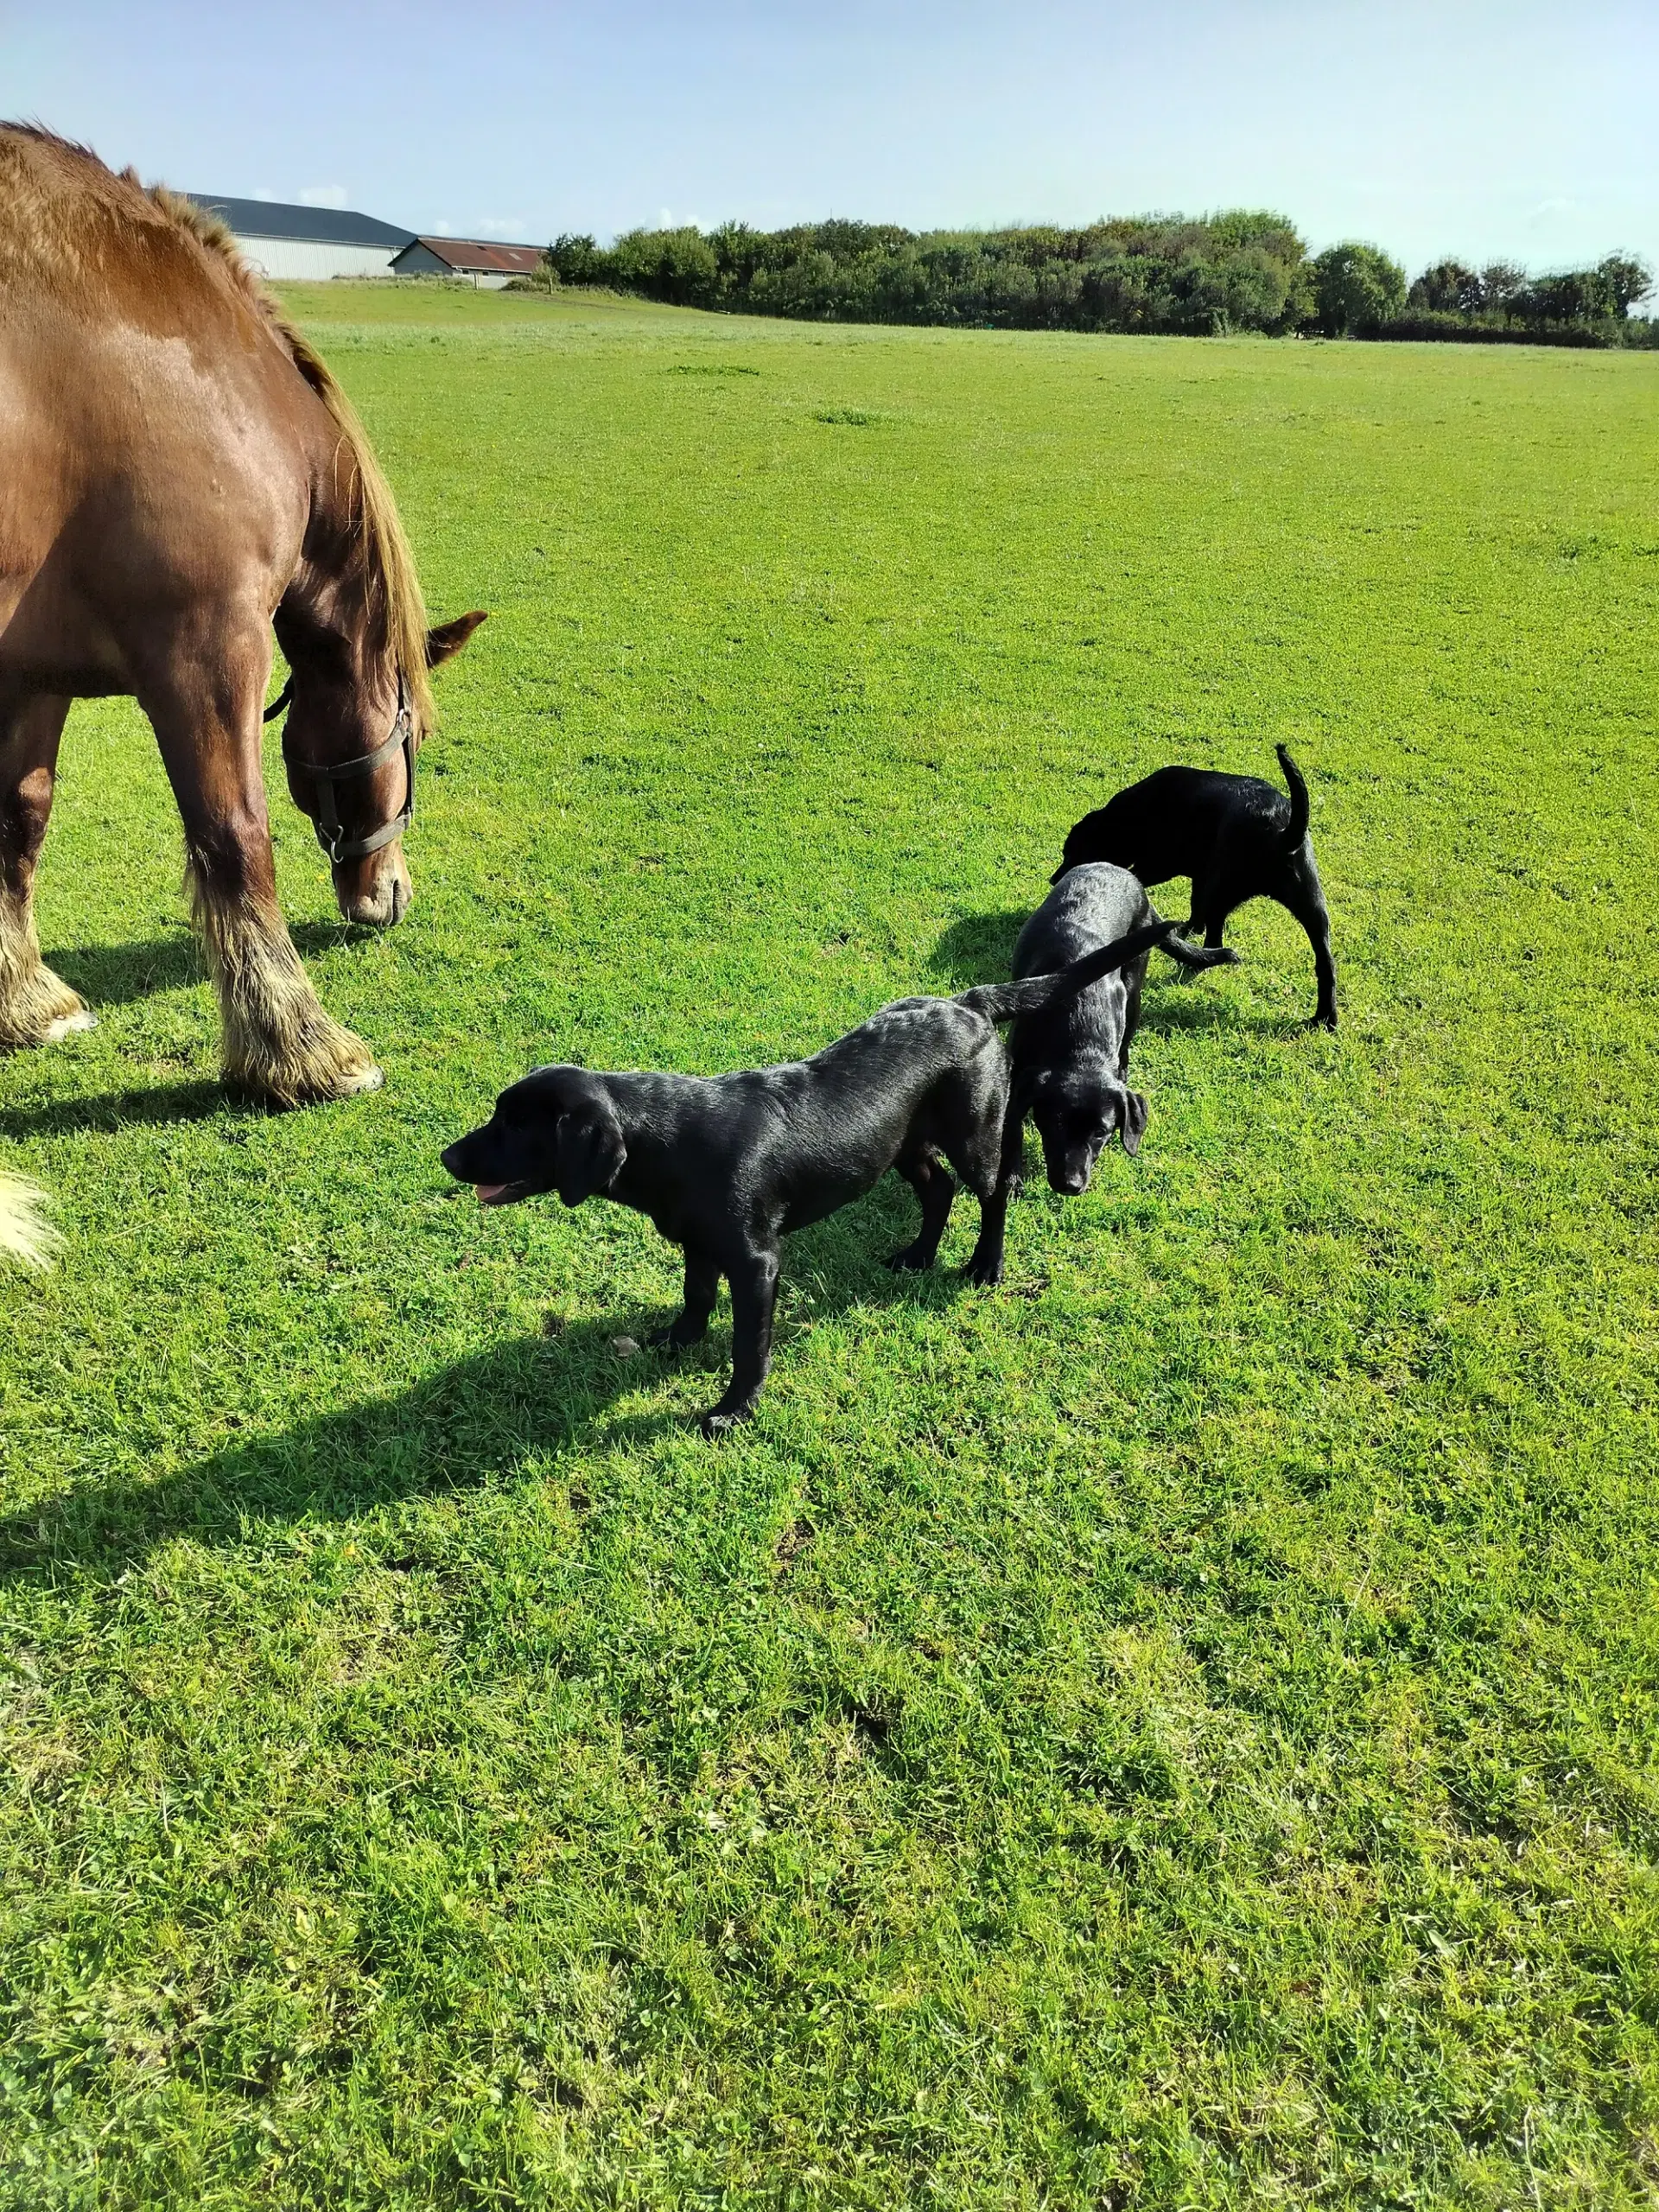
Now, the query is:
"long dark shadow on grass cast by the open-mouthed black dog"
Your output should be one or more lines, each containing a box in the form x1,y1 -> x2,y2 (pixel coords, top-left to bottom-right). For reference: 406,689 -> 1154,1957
0,1188 -> 982,1586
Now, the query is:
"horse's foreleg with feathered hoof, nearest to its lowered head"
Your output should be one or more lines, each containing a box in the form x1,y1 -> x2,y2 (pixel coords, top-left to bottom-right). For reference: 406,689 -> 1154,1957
143,655 -> 380,1106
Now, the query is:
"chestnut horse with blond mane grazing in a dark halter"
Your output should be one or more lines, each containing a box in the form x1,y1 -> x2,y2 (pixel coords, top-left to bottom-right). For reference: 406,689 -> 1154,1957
0,126 -> 485,1103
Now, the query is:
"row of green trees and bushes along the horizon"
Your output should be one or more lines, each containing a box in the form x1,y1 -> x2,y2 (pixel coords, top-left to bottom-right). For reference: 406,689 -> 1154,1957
546,208 -> 1659,345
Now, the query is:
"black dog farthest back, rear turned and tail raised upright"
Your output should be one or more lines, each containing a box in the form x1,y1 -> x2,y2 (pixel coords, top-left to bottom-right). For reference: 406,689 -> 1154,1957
1048,746 -> 1336,1028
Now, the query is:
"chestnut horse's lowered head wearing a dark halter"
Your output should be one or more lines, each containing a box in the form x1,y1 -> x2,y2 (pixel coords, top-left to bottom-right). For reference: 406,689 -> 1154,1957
272,608 -> 485,925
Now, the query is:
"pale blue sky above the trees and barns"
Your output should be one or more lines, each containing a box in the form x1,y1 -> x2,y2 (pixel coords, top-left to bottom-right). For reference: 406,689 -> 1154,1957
0,0 -> 1659,270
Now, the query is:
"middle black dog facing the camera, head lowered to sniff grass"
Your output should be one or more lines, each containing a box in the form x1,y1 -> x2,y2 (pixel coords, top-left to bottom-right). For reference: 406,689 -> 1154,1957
1002,861 -> 1239,1197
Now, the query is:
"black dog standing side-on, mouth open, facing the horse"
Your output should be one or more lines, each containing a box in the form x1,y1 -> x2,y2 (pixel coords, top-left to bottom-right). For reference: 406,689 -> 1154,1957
442,923 -> 1174,1435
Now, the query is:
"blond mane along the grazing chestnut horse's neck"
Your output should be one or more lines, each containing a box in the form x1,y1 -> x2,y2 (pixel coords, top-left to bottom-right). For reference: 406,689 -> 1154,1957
0,124 -> 434,730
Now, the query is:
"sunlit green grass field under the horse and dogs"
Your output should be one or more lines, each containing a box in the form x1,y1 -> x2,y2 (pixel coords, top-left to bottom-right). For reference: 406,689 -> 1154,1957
0,288 -> 1659,2212
